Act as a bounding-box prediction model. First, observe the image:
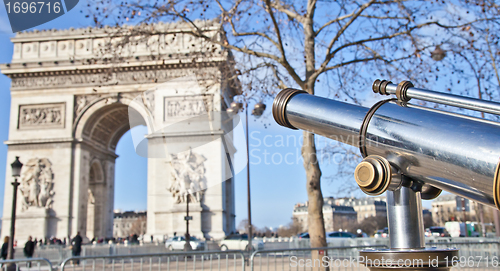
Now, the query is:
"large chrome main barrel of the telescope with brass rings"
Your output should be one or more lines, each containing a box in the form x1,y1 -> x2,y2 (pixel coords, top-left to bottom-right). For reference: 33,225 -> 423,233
273,89 -> 500,209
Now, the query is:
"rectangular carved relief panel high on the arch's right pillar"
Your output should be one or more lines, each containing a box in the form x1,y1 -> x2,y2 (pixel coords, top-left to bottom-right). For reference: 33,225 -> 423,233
164,95 -> 212,120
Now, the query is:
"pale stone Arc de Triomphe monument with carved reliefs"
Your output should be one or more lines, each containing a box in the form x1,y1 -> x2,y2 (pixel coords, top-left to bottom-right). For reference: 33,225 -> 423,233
0,23 -> 240,242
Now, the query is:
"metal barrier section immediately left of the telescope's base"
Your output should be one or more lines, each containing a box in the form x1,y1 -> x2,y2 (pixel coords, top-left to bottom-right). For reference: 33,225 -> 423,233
250,245 -> 387,271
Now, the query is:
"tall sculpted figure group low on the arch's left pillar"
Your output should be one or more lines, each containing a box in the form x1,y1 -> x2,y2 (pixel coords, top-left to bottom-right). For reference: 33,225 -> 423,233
19,158 -> 55,211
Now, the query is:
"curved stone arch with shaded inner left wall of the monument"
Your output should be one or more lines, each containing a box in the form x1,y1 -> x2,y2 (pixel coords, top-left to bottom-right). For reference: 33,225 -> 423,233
73,97 -> 150,240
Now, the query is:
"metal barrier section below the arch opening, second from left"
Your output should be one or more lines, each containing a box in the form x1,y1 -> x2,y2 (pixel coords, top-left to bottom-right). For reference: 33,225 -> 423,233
61,250 -> 245,271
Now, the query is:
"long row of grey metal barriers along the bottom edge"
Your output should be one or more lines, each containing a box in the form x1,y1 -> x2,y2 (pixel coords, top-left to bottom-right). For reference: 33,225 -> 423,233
0,241 -> 500,271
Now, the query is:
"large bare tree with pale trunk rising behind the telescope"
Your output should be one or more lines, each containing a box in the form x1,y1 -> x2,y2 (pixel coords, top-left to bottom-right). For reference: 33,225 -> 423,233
90,0 -> 498,262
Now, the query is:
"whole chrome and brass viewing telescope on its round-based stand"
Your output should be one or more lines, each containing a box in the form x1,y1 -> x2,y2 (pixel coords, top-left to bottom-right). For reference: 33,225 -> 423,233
273,80 -> 500,270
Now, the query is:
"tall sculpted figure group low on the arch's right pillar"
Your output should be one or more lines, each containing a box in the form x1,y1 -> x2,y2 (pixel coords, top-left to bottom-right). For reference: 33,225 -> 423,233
169,150 -> 207,203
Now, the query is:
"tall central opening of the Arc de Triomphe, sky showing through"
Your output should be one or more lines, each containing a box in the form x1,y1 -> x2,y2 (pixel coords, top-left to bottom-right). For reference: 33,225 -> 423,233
76,103 -> 147,241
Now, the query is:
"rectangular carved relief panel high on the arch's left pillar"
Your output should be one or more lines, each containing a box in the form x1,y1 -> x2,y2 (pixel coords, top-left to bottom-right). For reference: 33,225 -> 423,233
18,103 -> 65,129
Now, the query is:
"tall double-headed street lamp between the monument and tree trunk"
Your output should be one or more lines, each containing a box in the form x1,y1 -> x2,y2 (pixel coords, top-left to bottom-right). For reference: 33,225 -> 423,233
226,98 -> 266,251
